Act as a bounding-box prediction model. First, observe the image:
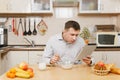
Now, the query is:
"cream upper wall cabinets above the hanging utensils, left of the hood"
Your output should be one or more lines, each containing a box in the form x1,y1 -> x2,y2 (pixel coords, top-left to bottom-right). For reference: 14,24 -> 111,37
0,0 -> 53,15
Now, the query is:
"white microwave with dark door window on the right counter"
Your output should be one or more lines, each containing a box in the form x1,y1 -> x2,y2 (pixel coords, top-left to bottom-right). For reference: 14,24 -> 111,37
96,32 -> 120,47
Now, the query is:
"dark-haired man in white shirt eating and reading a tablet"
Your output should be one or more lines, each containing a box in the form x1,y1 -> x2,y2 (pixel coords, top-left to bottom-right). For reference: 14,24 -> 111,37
43,20 -> 91,65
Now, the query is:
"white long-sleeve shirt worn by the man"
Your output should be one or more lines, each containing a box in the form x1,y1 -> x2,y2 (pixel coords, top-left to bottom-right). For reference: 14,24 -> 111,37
42,33 -> 85,64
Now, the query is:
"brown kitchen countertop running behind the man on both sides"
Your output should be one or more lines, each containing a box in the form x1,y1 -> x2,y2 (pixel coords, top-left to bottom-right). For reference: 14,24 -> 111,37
0,44 -> 120,54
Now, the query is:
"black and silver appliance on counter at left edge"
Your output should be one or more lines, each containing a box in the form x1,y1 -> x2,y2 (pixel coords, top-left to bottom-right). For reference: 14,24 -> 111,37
0,28 -> 8,47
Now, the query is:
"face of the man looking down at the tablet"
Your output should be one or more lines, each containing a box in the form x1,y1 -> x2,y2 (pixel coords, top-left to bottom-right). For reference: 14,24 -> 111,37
63,28 -> 80,43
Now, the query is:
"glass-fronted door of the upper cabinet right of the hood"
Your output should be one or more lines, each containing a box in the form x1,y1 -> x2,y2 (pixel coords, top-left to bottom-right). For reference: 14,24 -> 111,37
79,0 -> 100,13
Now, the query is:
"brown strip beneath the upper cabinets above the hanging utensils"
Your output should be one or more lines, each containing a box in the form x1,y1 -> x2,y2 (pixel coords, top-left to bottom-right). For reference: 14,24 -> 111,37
0,13 -> 53,17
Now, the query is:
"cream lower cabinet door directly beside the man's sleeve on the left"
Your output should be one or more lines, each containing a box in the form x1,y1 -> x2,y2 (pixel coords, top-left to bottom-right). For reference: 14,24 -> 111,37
29,51 -> 43,65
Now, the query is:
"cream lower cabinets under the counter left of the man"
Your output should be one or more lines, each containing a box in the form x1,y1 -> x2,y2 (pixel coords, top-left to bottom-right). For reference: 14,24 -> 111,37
4,50 -> 43,71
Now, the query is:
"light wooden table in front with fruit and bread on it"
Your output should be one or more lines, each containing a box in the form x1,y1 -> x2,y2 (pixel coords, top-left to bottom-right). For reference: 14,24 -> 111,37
0,65 -> 120,80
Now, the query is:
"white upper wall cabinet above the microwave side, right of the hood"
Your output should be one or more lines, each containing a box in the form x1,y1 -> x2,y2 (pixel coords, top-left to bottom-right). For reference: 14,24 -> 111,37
79,0 -> 120,13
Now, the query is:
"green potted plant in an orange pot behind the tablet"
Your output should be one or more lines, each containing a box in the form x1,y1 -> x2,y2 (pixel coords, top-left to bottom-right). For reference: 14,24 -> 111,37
80,27 -> 90,44
